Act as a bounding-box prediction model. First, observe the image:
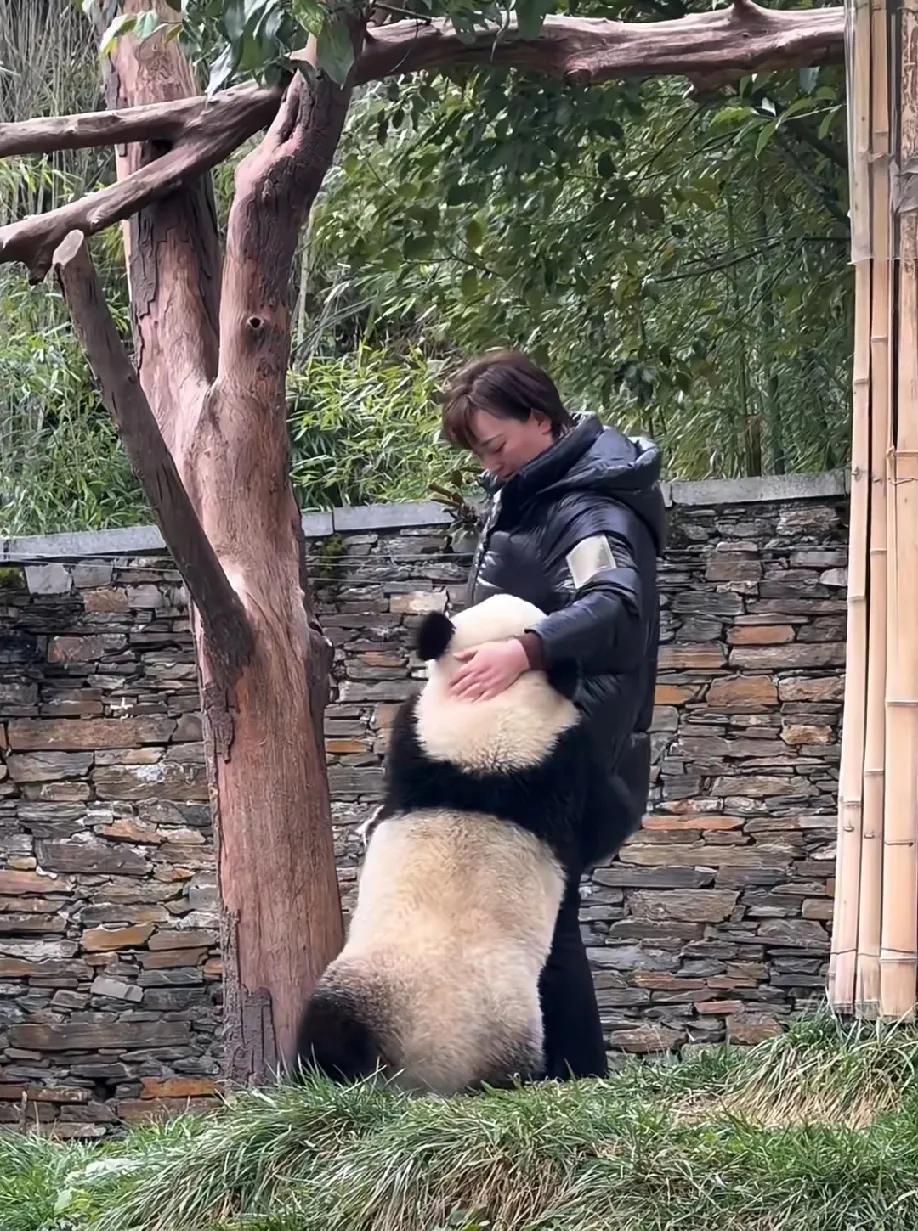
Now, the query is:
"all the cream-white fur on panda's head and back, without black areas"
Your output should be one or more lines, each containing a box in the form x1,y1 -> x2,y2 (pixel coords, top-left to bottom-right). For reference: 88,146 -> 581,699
307,595 -> 577,1094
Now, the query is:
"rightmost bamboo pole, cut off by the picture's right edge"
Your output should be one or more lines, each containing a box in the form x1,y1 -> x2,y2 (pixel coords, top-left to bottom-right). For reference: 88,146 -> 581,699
880,0 -> 918,1018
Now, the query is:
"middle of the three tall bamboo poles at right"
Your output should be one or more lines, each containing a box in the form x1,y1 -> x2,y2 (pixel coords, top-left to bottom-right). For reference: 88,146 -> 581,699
855,0 -> 891,1017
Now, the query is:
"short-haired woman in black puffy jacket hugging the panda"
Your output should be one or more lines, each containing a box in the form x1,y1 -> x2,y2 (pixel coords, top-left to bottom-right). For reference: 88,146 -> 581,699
443,351 -> 666,1080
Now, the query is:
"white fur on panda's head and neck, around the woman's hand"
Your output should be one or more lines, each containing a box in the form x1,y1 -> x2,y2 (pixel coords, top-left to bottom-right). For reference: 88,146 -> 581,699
417,595 -> 578,771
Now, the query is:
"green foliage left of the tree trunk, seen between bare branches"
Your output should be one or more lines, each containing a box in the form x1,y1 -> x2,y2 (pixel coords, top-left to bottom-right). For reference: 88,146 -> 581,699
0,0 -> 149,534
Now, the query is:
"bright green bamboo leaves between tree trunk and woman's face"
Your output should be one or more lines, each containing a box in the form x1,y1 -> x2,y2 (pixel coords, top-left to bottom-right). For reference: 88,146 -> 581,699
288,343 -> 470,508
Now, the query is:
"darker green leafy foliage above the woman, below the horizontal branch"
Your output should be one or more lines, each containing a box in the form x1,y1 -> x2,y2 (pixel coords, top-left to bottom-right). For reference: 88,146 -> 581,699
313,62 -> 852,476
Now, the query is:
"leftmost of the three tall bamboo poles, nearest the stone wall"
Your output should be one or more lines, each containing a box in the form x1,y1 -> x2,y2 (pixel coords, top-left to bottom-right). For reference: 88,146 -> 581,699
828,0 -> 871,1012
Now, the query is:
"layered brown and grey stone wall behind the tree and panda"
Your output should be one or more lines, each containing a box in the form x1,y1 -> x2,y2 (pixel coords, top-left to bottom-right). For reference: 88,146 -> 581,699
0,475 -> 847,1136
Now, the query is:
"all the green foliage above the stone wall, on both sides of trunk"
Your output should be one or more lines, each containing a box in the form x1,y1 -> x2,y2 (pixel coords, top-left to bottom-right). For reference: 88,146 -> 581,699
0,0 -> 852,534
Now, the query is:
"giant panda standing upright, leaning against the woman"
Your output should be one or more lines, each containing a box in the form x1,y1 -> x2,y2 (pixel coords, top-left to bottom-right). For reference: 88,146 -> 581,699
298,595 -> 625,1094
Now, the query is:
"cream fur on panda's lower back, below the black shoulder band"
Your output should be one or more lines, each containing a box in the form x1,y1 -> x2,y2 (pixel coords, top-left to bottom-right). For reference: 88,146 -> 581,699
340,811 -> 564,1094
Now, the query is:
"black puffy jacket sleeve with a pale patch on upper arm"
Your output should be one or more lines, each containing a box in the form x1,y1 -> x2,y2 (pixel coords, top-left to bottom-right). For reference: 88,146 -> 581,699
532,503 -> 656,672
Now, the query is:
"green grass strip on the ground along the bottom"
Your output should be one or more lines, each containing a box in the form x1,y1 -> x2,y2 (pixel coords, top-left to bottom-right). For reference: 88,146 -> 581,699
0,1016 -> 918,1231
